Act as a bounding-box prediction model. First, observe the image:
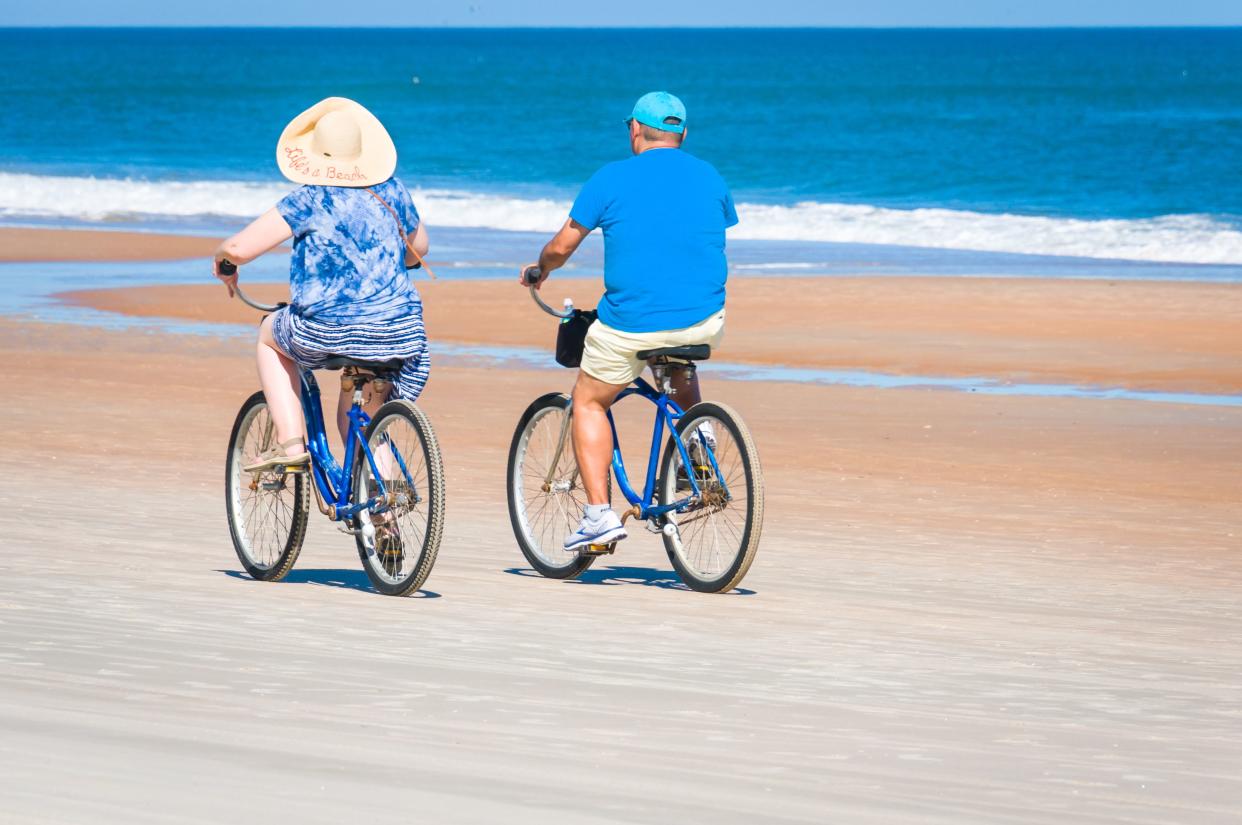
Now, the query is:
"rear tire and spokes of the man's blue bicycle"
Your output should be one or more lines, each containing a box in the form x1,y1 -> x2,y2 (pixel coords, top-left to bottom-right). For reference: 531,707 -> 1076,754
660,403 -> 764,593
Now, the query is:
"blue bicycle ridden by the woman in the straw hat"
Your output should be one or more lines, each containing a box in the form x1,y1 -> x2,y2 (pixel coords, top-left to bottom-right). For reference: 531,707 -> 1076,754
225,280 -> 445,596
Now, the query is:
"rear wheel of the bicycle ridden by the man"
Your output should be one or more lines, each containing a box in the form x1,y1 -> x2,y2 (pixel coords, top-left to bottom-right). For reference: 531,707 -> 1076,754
660,404 -> 764,593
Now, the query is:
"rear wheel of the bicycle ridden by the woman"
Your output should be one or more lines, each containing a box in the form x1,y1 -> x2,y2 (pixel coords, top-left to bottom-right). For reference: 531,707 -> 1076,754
353,401 -> 445,596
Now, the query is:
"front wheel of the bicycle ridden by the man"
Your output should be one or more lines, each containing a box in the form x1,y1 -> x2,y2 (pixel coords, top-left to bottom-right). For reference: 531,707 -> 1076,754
507,393 -> 596,579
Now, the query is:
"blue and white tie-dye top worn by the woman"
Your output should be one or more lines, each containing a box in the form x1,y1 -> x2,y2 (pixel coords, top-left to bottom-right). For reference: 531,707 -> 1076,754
276,178 -> 422,324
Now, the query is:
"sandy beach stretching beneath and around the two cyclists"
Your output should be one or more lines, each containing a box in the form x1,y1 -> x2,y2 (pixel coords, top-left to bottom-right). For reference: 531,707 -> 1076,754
0,227 -> 1242,824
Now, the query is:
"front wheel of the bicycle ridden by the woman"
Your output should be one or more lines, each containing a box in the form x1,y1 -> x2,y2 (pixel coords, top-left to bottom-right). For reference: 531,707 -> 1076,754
225,393 -> 312,581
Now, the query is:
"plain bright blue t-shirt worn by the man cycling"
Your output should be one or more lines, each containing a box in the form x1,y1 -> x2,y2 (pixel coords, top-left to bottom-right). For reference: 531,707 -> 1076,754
569,149 -> 738,332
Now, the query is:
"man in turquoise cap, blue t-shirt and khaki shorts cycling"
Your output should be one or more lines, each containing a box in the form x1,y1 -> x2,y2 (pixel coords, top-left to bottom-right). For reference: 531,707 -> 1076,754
519,92 -> 738,550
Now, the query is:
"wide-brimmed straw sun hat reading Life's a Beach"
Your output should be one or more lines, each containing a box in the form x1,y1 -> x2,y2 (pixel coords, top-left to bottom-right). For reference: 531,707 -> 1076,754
276,97 -> 396,188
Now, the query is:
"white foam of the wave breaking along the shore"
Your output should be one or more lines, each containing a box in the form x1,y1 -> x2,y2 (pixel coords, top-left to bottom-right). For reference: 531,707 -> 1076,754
0,173 -> 1242,263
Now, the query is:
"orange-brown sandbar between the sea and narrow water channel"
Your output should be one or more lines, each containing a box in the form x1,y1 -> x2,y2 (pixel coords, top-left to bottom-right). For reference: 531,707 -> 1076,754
62,277 -> 1242,394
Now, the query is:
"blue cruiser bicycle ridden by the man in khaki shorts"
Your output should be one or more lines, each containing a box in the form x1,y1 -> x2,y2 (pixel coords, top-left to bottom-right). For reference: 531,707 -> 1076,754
507,277 -> 764,593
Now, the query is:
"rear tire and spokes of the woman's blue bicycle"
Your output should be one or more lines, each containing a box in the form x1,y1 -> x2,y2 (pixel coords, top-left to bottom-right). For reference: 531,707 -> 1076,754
350,400 -> 445,596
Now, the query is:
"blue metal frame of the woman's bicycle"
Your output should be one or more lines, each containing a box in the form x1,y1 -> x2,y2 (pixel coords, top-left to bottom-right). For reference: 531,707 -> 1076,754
295,369 -> 414,522
